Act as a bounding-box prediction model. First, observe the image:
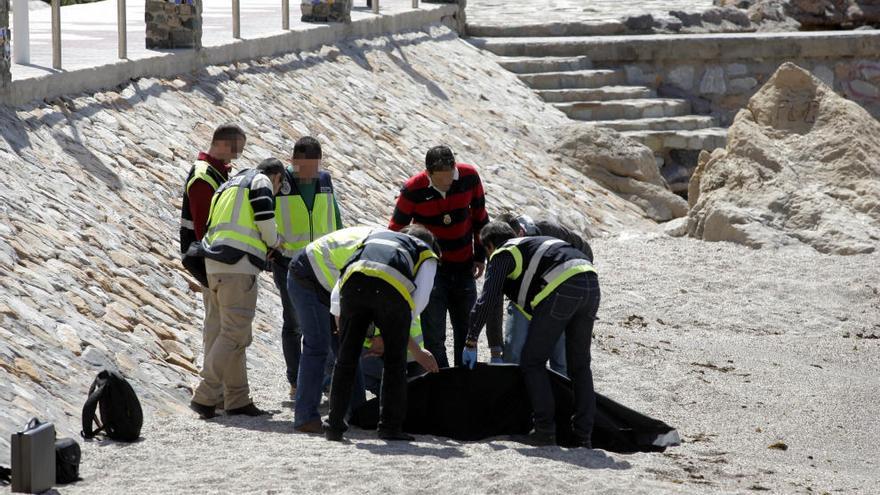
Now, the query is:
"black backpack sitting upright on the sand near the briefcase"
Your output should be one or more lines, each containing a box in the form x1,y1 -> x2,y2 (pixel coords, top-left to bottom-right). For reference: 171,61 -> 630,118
82,370 -> 144,442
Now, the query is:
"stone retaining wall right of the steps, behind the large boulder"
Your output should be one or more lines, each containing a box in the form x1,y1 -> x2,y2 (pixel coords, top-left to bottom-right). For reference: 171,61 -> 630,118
585,31 -> 880,125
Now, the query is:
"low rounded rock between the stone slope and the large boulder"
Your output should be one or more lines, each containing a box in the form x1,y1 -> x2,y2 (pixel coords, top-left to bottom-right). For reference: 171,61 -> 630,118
550,123 -> 687,222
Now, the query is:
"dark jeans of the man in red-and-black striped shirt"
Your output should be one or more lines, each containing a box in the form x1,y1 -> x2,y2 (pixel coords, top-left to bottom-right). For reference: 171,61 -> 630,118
422,264 -> 477,368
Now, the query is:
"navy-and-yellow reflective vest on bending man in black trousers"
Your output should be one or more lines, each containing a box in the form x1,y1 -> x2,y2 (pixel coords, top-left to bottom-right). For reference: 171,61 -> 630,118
340,230 -> 437,309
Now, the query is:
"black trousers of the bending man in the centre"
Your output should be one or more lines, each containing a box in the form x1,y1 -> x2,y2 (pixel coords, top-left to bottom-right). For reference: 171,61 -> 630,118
329,273 -> 412,431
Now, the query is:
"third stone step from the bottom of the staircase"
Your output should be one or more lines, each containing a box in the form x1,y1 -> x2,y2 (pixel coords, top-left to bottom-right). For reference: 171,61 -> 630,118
553,98 -> 691,121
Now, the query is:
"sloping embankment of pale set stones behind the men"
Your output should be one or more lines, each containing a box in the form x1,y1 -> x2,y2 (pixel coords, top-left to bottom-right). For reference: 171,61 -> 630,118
0,23 -> 647,460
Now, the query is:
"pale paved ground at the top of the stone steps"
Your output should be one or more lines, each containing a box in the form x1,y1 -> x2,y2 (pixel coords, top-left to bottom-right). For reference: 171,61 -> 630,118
467,0 -> 712,26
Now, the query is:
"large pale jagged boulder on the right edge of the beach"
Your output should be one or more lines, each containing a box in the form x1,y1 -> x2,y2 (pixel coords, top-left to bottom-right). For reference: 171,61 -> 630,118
688,63 -> 880,254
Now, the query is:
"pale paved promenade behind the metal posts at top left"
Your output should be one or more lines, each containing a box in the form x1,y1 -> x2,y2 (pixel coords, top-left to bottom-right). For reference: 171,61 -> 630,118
10,0 -> 438,80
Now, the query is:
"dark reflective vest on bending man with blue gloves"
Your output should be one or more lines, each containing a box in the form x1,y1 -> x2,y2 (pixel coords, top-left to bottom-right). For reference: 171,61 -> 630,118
489,236 -> 596,319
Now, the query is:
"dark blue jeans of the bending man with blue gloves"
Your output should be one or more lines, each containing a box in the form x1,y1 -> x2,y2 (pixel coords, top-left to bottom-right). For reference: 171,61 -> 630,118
520,273 -> 599,440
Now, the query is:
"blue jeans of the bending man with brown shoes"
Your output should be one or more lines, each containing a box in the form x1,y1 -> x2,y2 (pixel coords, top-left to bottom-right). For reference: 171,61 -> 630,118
287,276 -> 333,427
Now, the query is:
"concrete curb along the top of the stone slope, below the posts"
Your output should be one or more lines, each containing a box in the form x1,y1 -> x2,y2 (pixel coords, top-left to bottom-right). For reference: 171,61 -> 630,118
0,4 -> 458,106
